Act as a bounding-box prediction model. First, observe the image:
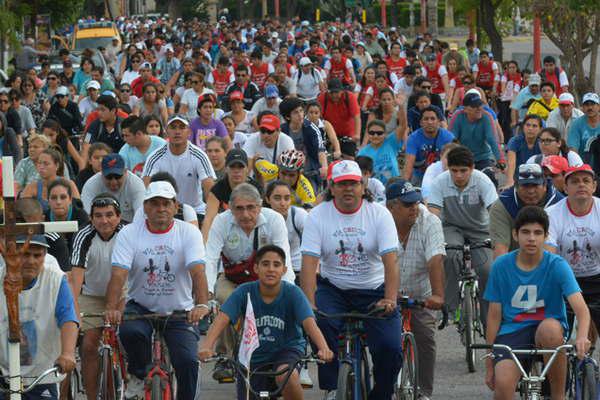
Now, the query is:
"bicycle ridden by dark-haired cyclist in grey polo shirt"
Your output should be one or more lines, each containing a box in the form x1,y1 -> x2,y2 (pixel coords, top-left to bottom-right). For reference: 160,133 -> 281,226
446,239 -> 492,372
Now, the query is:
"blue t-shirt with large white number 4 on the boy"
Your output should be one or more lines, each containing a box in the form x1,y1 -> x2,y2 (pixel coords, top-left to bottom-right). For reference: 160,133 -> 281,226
483,250 -> 581,335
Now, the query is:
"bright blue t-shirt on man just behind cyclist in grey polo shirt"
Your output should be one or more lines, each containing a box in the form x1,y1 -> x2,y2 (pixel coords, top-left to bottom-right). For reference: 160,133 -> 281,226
406,128 -> 454,178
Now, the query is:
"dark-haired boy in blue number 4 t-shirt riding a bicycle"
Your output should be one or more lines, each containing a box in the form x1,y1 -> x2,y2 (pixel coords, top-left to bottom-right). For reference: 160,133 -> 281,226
484,206 -> 590,400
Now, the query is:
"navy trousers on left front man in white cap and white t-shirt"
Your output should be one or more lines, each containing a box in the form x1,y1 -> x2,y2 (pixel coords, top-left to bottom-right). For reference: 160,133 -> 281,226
119,301 -> 200,400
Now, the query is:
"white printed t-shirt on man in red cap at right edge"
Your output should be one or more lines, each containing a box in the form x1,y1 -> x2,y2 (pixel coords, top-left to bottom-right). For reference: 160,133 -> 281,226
546,197 -> 600,278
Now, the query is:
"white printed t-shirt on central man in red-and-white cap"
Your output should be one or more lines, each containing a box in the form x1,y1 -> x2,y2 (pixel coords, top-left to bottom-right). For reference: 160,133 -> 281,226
301,201 -> 398,290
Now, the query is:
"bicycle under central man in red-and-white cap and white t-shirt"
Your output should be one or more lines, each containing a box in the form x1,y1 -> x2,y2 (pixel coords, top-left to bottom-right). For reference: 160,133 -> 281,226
315,308 -> 384,400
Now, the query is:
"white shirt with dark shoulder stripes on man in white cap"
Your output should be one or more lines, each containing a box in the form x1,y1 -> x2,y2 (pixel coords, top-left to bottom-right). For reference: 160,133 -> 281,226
142,142 -> 216,214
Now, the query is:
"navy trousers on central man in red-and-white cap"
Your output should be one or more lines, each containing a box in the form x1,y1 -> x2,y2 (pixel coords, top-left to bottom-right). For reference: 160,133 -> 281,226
315,279 -> 402,400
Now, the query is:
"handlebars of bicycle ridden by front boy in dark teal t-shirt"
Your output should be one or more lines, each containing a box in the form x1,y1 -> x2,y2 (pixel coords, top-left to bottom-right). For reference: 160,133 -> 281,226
203,354 -> 324,400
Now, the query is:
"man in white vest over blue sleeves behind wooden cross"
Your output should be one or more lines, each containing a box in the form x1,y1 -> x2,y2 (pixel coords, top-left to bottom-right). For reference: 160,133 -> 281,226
0,235 -> 79,400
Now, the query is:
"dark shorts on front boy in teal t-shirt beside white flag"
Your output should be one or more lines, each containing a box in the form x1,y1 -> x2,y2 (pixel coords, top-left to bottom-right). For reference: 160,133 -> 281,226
236,349 -> 302,400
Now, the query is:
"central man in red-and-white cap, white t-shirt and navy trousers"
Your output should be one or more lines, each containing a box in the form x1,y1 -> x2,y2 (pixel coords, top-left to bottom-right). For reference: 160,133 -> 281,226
301,160 -> 402,400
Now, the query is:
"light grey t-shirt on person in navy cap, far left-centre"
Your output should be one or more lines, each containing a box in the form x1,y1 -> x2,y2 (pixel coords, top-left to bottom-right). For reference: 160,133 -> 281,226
81,171 -> 146,222
